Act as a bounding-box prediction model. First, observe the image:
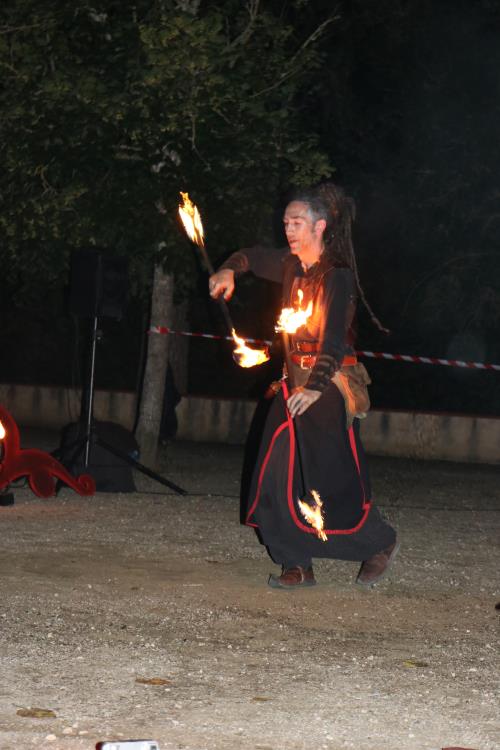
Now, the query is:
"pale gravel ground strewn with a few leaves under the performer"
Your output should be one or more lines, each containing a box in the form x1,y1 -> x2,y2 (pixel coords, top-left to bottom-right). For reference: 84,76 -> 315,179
0,432 -> 500,750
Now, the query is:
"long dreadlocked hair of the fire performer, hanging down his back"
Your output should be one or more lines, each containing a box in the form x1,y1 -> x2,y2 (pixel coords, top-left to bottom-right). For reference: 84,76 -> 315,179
294,182 -> 390,333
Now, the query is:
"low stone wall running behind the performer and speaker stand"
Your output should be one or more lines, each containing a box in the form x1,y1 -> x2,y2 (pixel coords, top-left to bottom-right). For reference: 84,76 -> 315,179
0,385 -> 500,464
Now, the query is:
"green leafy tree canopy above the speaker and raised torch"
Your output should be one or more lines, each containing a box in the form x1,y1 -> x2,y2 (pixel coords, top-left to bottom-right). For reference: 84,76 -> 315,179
0,0 -> 335,460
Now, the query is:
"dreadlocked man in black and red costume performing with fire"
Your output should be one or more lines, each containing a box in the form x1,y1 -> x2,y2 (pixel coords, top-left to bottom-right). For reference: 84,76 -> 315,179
209,183 -> 399,589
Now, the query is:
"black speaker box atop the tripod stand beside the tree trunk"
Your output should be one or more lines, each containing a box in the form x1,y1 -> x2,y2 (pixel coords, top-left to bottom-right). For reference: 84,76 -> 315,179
68,248 -> 128,320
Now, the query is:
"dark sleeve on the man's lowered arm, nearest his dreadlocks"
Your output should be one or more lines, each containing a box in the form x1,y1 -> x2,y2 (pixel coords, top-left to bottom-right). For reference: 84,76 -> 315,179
306,268 -> 356,391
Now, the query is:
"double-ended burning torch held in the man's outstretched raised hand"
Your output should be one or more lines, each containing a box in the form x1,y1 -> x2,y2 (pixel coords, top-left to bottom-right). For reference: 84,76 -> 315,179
179,192 -> 269,367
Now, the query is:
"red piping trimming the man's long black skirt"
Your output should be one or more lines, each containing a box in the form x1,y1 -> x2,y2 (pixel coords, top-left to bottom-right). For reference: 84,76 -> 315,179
246,381 -> 372,535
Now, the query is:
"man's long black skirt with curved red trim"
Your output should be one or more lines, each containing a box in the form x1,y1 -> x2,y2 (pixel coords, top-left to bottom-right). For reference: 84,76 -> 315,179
246,382 -> 395,567
